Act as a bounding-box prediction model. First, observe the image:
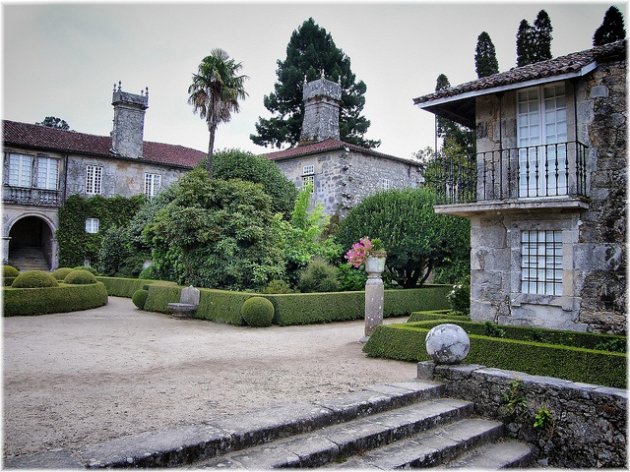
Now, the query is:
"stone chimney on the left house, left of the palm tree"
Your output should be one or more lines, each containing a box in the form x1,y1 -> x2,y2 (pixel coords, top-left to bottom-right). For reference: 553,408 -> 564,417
112,82 -> 149,159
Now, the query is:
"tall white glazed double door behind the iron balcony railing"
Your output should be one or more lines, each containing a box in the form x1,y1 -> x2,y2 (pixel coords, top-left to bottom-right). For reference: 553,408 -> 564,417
516,82 -> 568,198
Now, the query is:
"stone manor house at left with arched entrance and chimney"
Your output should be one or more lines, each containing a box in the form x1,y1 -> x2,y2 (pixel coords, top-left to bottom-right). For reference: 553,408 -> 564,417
2,83 -> 205,269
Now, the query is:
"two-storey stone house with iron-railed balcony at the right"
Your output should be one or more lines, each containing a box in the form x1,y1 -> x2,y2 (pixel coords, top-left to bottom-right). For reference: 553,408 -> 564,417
414,41 -> 628,333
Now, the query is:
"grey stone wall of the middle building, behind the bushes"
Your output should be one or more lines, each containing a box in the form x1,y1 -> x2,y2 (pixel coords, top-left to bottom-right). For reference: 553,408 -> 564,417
276,150 -> 422,217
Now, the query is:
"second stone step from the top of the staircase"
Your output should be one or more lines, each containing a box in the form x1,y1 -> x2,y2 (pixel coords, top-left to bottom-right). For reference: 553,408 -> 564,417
194,398 -> 476,469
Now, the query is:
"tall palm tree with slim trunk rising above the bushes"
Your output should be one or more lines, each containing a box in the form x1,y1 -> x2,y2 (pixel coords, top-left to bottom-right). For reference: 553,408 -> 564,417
188,49 -> 248,176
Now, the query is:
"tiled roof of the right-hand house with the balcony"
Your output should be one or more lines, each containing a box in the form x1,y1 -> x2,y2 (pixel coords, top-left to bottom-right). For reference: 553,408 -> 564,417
413,40 -> 626,105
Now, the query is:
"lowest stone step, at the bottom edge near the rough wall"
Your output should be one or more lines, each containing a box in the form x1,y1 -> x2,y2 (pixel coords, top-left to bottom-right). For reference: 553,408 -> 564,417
444,440 -> 534,470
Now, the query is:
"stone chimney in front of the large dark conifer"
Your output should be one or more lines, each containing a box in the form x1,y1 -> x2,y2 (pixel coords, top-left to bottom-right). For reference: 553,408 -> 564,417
300,71 -> 341,142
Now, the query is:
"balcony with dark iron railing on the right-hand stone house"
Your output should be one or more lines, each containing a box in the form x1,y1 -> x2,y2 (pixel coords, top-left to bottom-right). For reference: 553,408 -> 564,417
432,141 -> 588,216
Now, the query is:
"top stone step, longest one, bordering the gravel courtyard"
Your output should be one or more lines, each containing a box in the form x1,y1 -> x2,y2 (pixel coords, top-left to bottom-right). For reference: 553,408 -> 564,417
4,379 -> 444,469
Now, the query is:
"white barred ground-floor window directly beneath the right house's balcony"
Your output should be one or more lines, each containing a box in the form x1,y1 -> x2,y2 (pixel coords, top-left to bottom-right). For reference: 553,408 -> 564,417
521,230 -> 564,296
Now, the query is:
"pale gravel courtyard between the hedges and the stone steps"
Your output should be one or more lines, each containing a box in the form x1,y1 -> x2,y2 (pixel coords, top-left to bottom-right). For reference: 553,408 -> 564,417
3,297 -> 416,456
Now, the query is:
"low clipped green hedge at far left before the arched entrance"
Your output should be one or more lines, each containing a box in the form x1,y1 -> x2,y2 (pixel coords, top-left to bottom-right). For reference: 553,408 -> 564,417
3,283 -> 107,316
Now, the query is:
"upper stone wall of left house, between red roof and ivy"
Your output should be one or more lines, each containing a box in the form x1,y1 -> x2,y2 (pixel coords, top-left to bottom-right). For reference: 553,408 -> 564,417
67,156 -> 189,197
